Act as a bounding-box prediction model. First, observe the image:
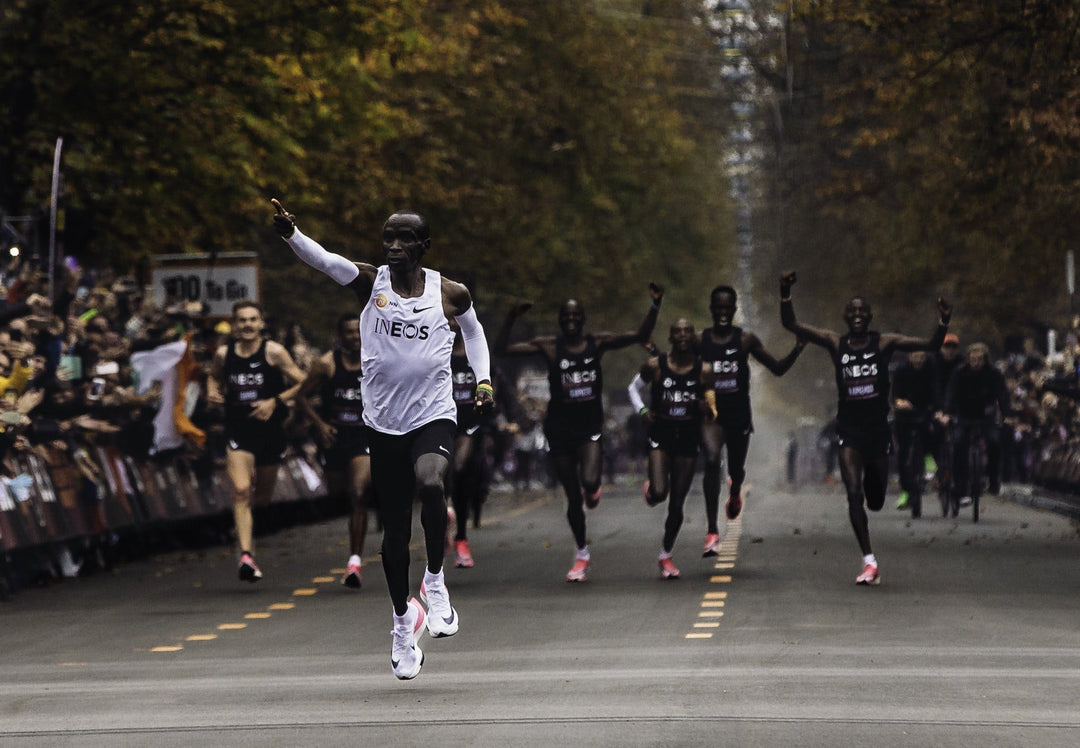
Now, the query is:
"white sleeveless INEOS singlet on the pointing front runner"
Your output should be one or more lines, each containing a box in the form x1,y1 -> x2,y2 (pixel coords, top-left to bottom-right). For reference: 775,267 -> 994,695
360,266 -> 457,435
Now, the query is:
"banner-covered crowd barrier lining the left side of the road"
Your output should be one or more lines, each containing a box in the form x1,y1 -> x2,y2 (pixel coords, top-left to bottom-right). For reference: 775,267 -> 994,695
0,446 -> 327,591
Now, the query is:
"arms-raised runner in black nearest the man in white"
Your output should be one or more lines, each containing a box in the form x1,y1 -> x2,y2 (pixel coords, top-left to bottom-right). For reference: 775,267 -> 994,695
495,283 -> 664,582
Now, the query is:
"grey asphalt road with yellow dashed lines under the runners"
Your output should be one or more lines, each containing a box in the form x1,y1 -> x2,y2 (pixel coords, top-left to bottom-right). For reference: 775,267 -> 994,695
0,446 -> 1080,747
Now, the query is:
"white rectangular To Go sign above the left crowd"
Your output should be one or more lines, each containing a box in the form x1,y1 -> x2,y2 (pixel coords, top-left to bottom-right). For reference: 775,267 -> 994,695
150,253 -> 260,317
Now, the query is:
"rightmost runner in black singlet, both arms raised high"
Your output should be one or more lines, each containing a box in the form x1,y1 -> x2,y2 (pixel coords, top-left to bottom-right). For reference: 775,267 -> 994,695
780,272 -> 953,584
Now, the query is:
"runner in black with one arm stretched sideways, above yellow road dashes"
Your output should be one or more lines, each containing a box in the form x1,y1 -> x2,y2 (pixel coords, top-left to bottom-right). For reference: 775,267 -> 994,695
700,286 -> 806,557
